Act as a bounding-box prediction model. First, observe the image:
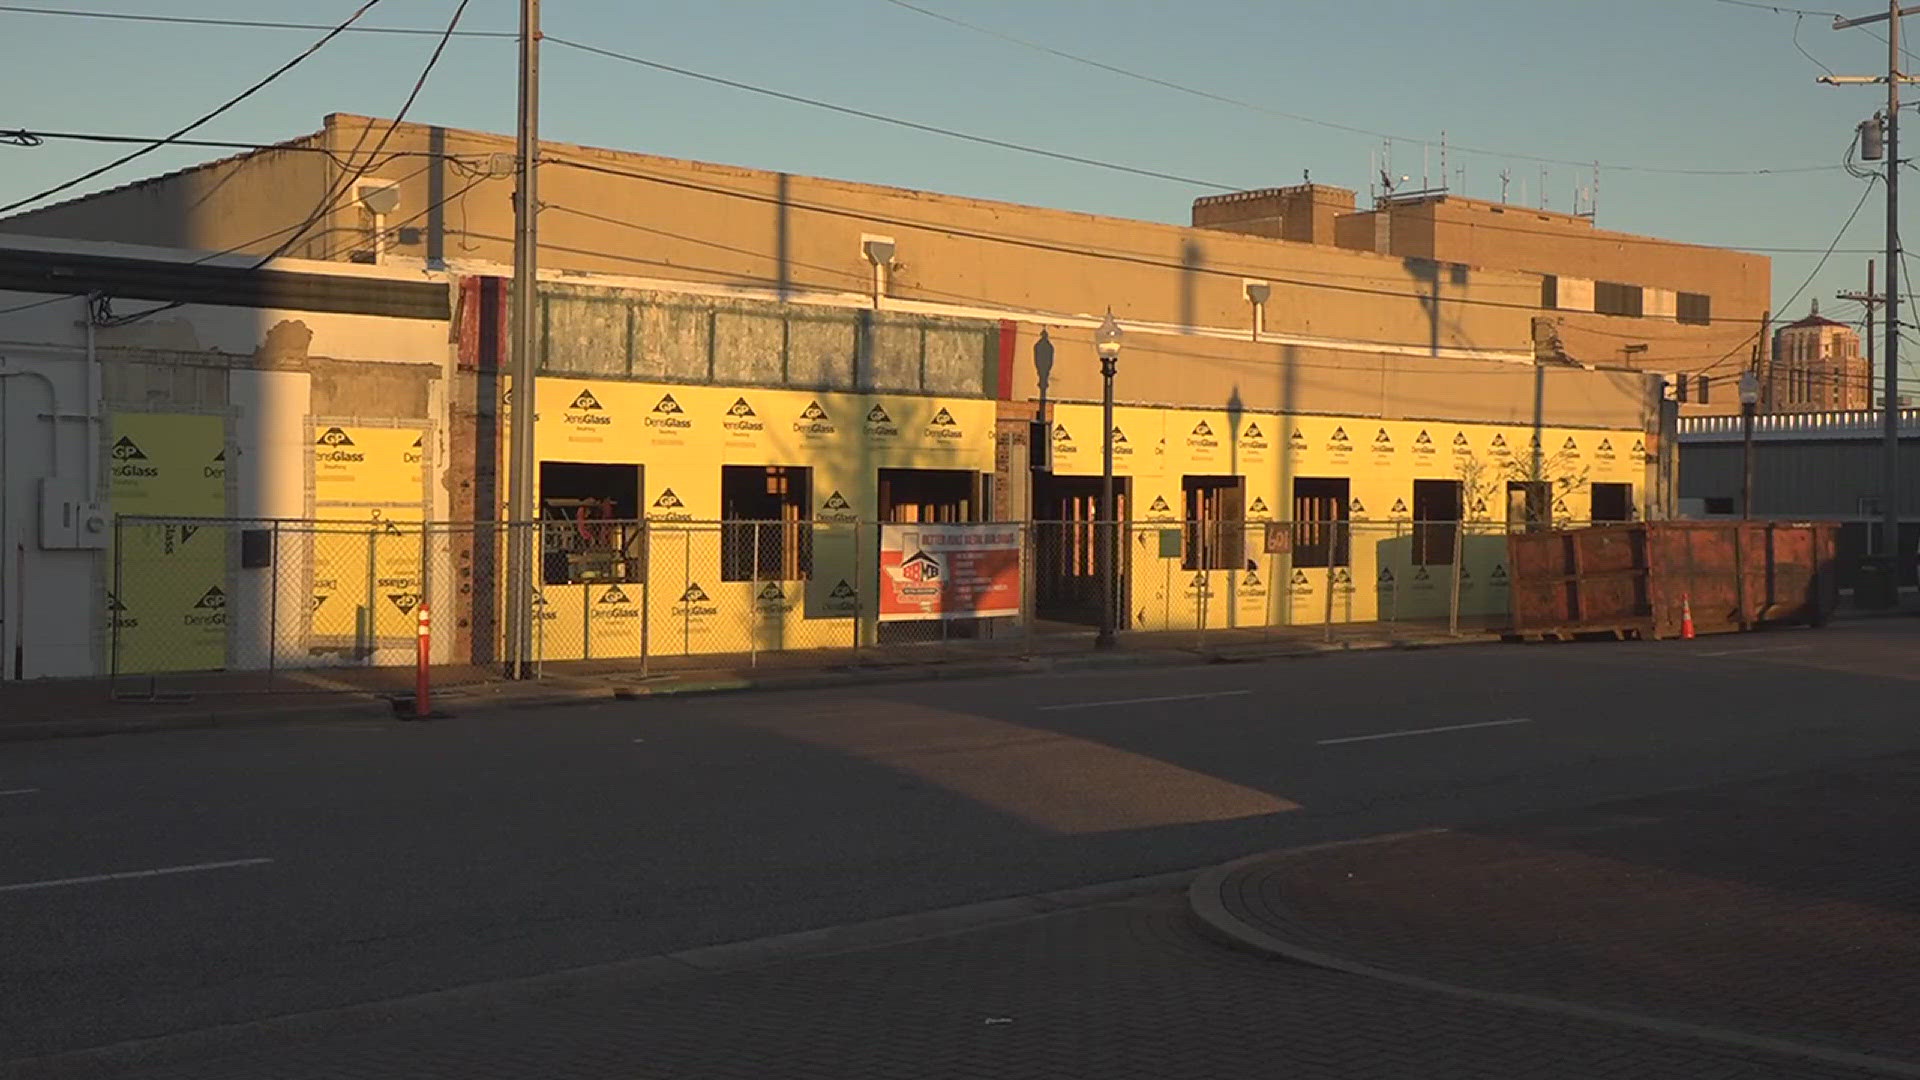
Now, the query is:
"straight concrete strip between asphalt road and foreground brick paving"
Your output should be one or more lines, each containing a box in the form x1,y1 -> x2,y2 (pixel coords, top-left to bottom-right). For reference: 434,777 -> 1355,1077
0,871 -> 1198,1080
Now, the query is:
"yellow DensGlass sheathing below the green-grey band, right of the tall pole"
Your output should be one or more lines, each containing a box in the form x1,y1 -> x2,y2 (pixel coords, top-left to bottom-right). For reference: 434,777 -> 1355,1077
503,377 -> 995,659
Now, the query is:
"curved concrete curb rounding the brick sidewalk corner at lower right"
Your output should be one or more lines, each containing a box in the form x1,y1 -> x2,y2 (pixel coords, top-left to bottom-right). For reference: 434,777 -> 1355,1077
1187,845 -> 1920,1078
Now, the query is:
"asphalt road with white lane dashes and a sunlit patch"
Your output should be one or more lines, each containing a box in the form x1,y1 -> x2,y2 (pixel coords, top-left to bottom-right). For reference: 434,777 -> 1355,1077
0,621 -> 1920,1063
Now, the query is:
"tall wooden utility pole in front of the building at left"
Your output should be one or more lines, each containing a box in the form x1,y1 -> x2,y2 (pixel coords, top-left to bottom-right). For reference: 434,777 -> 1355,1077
507,0 -> 540,678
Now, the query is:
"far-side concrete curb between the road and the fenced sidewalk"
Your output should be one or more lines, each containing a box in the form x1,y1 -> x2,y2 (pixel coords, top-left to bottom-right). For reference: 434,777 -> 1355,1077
0,634 -> 1500,744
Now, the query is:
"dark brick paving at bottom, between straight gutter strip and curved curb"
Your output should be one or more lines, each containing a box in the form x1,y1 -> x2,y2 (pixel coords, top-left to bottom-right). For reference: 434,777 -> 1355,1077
18,894 -> 1870,1080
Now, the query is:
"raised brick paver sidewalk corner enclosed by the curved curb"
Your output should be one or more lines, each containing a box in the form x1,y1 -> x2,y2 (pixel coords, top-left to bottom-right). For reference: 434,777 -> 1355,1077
1219,755 -> 1920,1063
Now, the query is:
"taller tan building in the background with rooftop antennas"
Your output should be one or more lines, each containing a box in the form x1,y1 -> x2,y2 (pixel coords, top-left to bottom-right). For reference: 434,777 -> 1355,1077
1192,184 -> 1772,413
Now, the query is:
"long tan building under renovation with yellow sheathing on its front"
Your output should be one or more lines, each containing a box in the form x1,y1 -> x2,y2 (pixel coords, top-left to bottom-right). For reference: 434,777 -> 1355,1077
0,115 -> 1724,663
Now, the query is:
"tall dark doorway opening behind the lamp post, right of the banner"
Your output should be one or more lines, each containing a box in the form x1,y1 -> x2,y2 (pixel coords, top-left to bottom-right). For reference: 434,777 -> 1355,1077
1033,473 -> 1133,628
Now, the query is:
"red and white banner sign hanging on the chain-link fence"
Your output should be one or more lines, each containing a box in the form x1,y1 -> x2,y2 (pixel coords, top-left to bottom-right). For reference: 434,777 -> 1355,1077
879,525 -> 1020,623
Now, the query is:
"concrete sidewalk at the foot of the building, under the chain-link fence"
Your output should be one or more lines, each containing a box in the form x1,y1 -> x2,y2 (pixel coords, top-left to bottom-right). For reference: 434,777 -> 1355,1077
0,623 -> 1498,742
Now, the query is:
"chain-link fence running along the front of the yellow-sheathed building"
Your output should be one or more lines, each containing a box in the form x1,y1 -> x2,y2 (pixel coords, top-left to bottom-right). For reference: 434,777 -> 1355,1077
104,511 -> 1543,690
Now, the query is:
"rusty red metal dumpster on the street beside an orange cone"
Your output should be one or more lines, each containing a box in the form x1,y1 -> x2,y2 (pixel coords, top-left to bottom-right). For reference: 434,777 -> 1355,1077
1507,521 -> 1839,638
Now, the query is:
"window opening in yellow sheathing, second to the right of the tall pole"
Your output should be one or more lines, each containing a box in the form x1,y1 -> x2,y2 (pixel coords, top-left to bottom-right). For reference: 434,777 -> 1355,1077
720,465 -> 814,580
